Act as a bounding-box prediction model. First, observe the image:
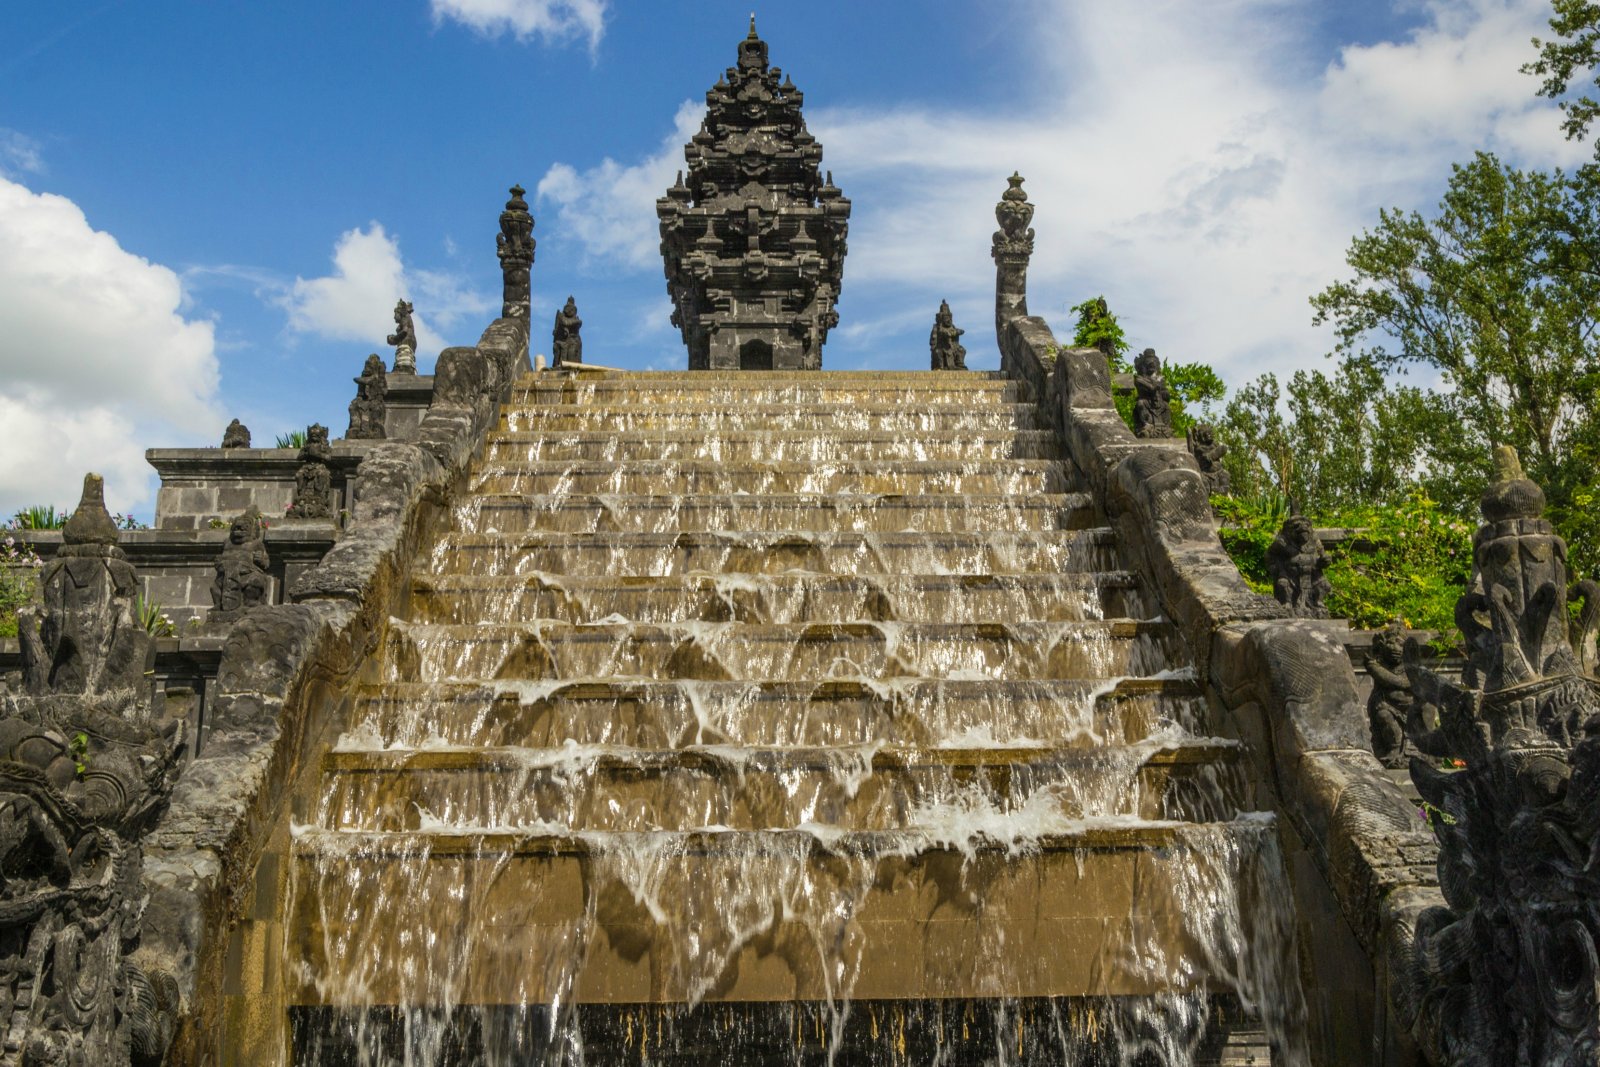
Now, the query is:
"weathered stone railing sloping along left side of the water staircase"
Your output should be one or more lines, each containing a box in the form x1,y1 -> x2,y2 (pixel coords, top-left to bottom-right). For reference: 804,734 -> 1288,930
138,317 -> 528,1064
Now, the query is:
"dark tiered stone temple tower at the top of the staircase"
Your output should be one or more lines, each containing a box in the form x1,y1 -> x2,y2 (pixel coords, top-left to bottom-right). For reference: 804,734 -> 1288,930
656,18 -> 850,370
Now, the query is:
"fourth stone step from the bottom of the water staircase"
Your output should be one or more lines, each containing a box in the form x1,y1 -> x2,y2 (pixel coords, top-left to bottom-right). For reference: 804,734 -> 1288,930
379,619 -> 1178,681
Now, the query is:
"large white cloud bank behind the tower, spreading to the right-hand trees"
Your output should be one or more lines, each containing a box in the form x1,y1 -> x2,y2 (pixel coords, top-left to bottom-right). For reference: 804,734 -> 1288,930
541,0 -> 1587,384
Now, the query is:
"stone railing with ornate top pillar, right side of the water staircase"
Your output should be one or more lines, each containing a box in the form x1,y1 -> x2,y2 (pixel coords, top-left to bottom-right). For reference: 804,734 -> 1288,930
995,179 -> 1442,1064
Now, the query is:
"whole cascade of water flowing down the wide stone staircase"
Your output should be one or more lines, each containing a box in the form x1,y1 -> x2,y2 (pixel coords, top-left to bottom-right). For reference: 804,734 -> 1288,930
283,373 -> 1294,1067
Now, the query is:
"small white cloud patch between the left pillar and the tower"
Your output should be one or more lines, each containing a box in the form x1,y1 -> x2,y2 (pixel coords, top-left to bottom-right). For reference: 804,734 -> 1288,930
534,101 -> 706,270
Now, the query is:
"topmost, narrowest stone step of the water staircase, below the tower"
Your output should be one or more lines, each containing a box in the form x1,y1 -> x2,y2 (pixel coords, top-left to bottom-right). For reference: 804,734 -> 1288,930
510,378 -> 1032,406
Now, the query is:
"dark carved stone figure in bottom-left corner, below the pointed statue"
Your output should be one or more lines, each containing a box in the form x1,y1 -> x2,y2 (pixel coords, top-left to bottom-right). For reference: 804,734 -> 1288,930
0,691 -> 184,1067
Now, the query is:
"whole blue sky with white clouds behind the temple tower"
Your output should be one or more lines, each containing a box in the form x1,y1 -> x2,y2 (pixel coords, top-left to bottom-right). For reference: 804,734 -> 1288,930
0,0 -> 1586,515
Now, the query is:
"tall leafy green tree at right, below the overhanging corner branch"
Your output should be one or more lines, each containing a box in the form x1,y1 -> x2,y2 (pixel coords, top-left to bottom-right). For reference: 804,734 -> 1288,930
1312,154 -> 1600,560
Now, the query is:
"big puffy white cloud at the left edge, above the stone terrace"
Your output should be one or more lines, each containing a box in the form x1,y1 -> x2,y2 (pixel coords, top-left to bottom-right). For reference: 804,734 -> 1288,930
0,178 -> 224,515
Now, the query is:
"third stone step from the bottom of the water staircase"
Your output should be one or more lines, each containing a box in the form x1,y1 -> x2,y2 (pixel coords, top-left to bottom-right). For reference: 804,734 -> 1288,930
341,672 -> 1206,749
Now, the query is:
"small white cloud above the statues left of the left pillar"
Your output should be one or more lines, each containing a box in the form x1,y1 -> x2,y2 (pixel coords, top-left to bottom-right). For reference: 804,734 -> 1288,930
277,222 -> 494,358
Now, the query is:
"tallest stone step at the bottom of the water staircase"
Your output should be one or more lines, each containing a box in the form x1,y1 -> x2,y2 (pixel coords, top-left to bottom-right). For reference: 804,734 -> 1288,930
285,811 -> 1274,1008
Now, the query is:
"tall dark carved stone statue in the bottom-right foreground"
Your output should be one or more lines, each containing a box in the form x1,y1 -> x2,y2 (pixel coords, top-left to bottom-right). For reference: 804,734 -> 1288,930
1390,448 -> 1600,1067
